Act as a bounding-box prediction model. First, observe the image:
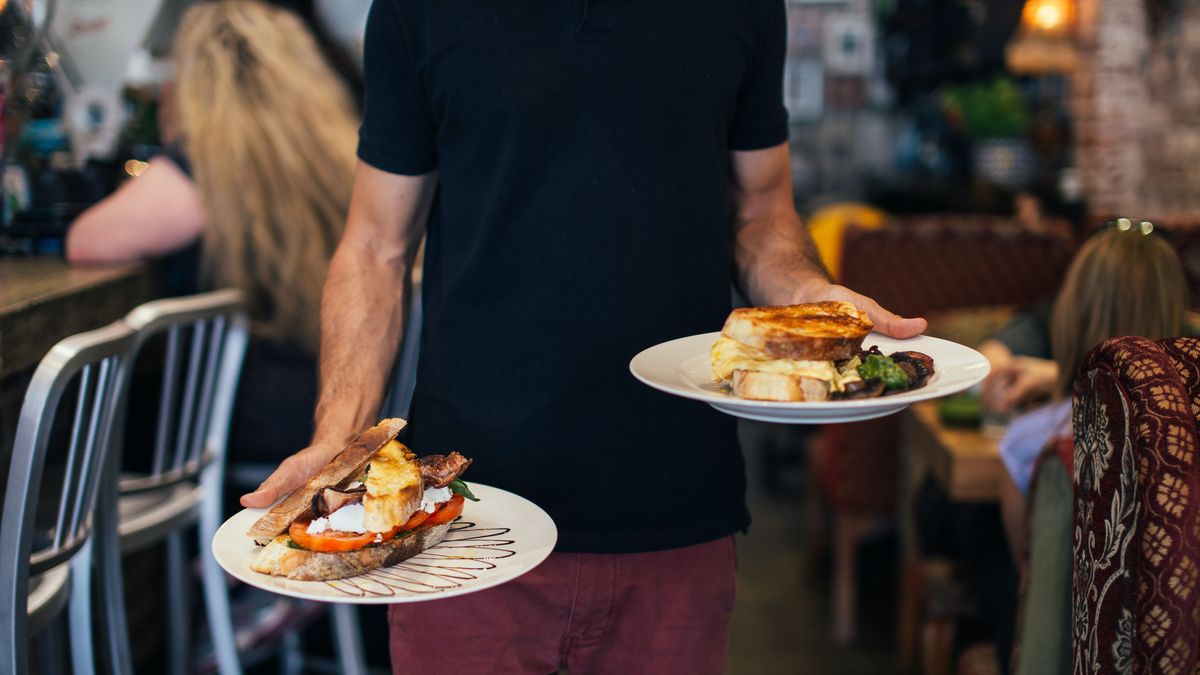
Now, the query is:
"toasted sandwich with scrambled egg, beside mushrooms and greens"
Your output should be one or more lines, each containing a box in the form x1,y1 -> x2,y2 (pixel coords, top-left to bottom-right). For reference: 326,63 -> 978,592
709,301 -> 872,401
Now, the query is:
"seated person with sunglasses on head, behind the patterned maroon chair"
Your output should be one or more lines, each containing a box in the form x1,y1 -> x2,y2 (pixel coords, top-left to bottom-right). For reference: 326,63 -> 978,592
1000,226 -> 1188,557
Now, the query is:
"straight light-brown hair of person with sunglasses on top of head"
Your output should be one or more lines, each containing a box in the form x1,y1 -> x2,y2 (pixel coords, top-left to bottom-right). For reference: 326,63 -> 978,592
1050,227 -> 1188,399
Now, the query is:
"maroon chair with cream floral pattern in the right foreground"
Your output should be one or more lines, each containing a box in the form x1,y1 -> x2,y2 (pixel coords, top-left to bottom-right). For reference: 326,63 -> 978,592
1072,338 -> 1200,675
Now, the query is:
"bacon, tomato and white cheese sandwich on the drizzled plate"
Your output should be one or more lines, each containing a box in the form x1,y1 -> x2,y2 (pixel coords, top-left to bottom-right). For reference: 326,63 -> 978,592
247,419 -> 475,581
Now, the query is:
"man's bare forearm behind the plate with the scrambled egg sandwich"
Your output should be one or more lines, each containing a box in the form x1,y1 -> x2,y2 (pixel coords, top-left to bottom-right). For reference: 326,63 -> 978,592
733,211 -> 829,305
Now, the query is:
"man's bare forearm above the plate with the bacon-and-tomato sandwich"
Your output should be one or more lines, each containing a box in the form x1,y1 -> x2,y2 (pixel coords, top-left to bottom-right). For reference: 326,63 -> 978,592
313,234 -> 413,448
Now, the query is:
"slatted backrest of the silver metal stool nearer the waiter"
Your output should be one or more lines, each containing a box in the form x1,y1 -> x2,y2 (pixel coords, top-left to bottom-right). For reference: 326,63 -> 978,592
120,289 -> 248,494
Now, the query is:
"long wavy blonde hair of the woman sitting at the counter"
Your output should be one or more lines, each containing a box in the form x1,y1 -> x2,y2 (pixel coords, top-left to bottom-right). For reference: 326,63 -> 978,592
174,0 -> 358,352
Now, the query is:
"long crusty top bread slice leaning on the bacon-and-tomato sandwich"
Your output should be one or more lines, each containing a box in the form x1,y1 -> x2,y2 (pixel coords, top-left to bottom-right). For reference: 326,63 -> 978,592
246,418 -> 408,546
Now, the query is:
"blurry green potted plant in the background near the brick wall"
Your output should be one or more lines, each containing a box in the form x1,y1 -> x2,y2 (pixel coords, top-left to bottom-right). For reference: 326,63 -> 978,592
941,77 -> 1037,190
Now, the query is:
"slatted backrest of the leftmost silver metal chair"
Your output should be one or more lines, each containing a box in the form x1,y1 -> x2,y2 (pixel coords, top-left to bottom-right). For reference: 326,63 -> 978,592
0,322 -> 136,673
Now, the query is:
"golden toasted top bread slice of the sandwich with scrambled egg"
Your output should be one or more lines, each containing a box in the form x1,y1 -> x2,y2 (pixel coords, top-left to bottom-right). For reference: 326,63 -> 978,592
721,301 -> 874,360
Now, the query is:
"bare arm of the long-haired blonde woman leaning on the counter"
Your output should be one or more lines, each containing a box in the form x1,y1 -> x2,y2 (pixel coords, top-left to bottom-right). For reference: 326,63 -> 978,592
66,157 -> 205,263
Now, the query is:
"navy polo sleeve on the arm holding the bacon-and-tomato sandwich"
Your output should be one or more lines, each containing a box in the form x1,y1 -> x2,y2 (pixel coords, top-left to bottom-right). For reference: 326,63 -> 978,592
359,0 -> 438,175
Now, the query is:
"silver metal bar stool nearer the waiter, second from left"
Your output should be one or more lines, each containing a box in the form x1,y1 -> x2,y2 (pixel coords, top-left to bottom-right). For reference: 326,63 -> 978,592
97,289 -> 248,675
